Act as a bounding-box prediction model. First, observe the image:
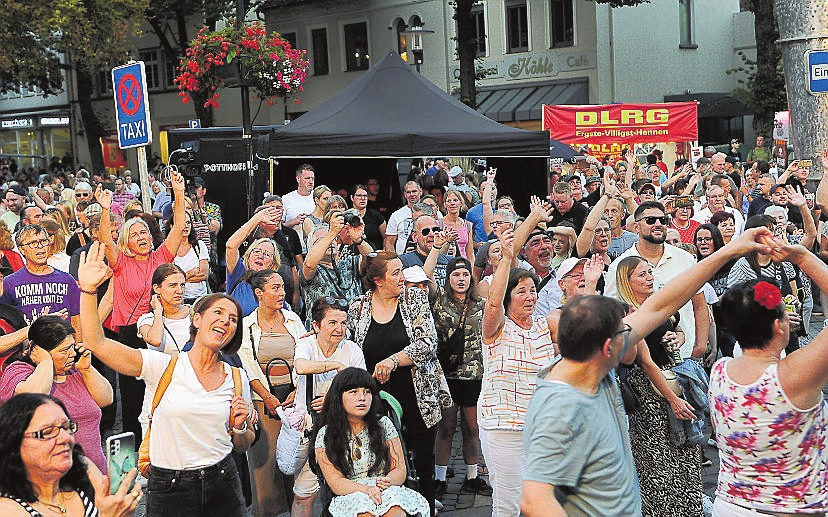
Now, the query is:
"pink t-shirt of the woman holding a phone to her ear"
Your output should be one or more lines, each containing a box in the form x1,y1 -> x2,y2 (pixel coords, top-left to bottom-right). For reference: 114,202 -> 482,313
0,361 -> 107,474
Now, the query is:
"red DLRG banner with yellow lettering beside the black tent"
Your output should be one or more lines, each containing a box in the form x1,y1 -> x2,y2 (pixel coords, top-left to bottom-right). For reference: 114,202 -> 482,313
543,102 -> 698,144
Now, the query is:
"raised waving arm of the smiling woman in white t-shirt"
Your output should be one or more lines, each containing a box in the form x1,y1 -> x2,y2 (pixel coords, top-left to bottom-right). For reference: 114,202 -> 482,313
78,242 -> 144,377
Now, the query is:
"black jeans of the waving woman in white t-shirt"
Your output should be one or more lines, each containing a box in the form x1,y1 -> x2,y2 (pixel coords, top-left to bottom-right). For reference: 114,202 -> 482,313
147,455 -> 245,517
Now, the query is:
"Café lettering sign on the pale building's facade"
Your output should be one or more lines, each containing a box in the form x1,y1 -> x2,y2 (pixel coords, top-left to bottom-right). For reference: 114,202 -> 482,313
449,51 -> 597,81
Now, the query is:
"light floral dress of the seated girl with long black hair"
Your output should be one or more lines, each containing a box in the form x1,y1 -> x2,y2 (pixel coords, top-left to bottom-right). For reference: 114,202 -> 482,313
314,417 -> 430,517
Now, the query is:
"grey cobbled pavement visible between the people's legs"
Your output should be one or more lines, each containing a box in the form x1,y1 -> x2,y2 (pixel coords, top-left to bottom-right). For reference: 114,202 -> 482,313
135,314 -> 828,517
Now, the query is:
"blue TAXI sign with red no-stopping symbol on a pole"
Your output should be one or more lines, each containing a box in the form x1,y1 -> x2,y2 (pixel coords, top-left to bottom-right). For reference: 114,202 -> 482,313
112,61 -> 152,149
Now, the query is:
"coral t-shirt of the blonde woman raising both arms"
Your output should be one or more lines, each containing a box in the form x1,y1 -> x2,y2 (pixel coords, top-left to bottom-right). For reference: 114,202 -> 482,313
112,244 -> 175,327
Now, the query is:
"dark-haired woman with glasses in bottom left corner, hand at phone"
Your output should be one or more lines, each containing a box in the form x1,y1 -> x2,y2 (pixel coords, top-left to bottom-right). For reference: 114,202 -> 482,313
0,393 -> 141,517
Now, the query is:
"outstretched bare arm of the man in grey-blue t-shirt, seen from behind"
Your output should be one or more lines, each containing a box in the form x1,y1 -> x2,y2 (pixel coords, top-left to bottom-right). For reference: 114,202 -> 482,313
624,227 -> 777,342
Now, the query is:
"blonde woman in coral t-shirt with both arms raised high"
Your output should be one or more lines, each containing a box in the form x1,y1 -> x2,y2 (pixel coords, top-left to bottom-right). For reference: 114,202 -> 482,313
95,172 -> 185,444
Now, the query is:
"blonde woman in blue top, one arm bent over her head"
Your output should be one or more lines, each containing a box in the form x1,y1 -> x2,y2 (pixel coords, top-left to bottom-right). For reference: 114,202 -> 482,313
225,207 -> 281,316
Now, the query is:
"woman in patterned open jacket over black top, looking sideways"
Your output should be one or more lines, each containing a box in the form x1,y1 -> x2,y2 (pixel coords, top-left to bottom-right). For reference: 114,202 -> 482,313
348,251 -> 451,514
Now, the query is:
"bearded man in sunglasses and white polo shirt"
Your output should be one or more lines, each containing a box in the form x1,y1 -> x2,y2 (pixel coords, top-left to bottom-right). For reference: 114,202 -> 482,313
604,200 -> 708,359
